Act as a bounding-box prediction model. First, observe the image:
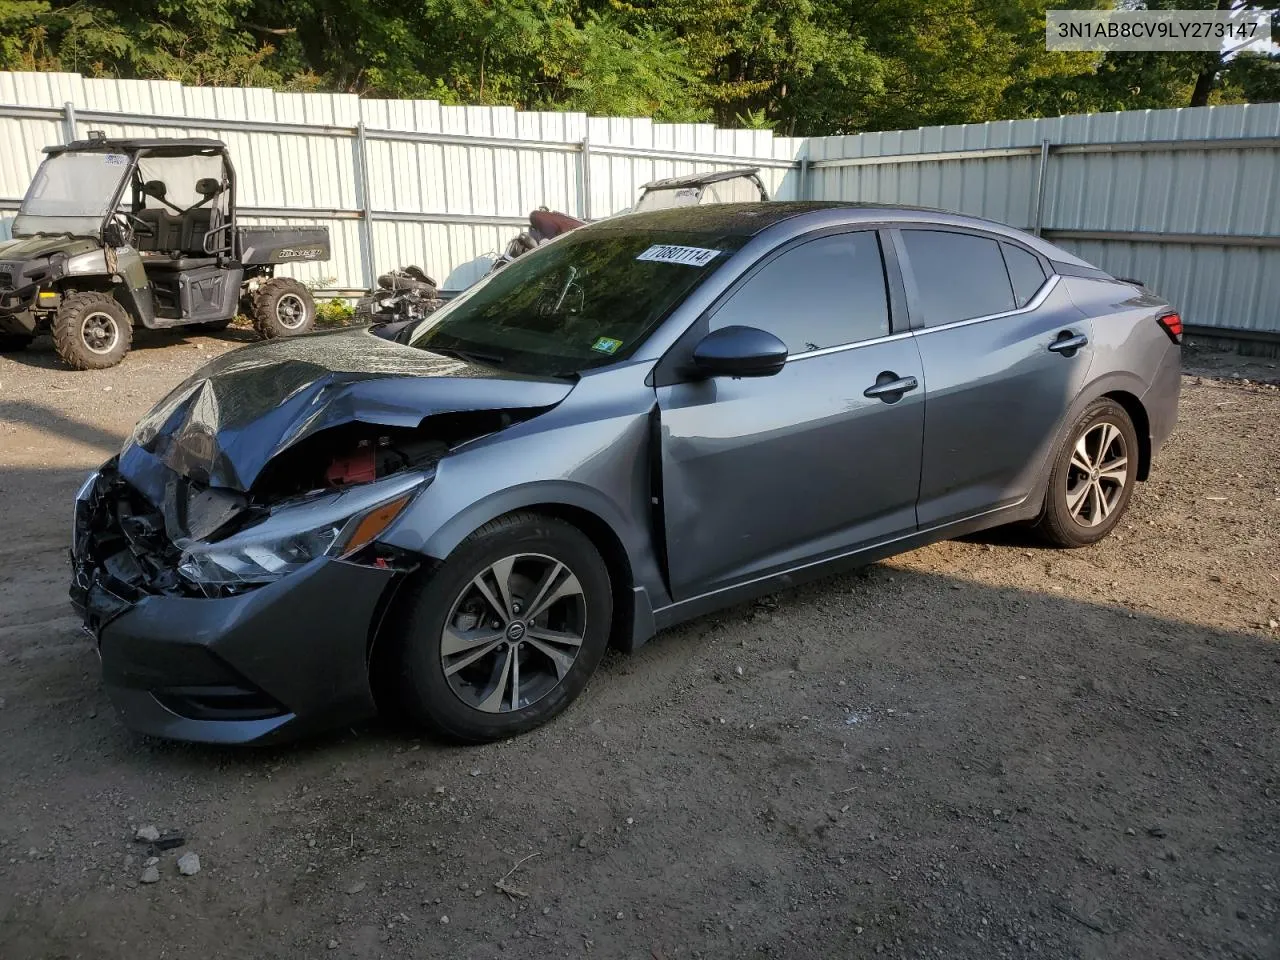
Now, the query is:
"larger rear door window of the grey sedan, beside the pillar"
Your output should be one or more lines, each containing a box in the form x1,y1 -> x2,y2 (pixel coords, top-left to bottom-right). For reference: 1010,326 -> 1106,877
902,230 -> 1014,326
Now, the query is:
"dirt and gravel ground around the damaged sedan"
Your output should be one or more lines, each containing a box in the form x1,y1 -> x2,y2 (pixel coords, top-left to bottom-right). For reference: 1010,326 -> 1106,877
0,330 -> 1280,960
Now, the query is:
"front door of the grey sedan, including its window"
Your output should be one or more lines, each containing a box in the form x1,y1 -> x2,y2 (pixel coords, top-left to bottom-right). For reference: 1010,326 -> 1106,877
658,230 -> 924,600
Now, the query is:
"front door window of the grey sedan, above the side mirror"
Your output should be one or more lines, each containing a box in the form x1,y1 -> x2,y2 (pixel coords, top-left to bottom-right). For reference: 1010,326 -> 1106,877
709,230 -> 890,356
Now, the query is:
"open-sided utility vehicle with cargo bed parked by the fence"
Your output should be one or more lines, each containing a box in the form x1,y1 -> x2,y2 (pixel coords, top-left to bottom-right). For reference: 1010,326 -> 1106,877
0,132 -> 329,370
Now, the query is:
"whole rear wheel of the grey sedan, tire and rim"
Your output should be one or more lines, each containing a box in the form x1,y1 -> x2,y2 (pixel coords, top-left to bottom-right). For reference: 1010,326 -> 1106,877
1037,398 -> 1139,548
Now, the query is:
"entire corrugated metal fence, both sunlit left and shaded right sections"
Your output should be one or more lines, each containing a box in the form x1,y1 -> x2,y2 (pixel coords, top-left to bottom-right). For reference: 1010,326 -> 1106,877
0,73 -> 1280,339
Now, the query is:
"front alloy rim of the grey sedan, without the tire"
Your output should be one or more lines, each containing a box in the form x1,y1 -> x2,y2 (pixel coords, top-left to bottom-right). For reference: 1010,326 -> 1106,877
440,553 -> 586,713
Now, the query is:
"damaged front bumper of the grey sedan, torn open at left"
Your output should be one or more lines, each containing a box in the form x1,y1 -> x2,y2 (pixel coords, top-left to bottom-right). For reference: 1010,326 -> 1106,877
70,463 -> 403,744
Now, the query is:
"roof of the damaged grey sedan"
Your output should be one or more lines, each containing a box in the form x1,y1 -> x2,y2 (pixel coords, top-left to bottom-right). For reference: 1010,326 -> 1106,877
580,200 -> 1092,266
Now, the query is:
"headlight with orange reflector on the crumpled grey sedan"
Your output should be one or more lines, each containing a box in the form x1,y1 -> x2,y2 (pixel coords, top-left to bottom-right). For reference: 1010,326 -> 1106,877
178,474 -> 429,586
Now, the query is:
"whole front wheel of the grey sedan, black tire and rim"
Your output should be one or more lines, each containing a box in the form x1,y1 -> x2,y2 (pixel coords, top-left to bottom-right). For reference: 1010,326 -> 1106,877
389,513 -> 613,744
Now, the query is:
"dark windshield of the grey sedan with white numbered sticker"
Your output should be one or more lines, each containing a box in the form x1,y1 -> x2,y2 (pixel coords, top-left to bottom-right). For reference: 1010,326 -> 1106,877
410,228 -> 745,376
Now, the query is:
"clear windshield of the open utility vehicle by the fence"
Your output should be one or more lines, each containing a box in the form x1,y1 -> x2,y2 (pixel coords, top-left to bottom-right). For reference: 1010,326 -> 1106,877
13,150 -> 129,237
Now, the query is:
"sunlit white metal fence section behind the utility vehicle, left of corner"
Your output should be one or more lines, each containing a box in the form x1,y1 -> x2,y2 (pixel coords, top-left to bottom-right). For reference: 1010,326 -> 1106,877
0,73 -> 803,293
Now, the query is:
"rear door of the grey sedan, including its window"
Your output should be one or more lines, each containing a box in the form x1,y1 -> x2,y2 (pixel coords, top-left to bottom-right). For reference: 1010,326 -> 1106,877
896,227 -> 1093,529
